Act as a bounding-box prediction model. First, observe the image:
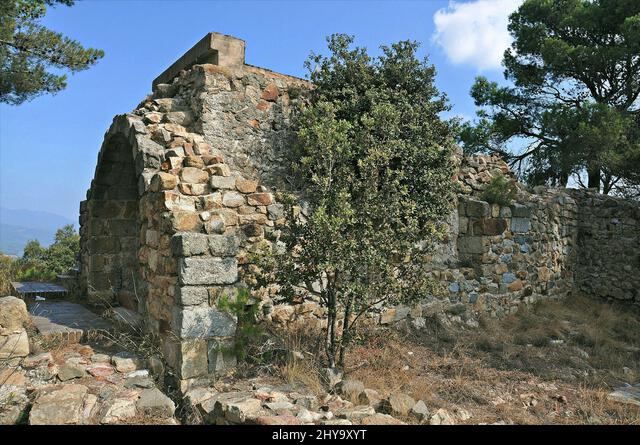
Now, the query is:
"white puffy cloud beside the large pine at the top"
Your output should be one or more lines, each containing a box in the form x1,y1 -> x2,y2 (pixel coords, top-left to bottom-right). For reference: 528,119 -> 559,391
433,0 -> 523,70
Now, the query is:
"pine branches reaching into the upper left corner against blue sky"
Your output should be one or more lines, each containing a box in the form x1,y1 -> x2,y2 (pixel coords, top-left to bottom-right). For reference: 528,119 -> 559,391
0,0 -> 104,105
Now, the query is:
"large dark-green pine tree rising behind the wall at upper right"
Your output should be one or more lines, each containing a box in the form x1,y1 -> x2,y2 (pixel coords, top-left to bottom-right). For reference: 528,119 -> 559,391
461,0 -> 640,193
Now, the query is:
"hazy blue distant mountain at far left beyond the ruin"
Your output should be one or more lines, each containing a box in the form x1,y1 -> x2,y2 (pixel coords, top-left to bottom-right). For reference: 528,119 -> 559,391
0,207 -> 74,256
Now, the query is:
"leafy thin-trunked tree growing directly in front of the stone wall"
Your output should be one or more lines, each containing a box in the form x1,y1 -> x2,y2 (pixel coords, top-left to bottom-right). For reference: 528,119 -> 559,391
263,34 -> 454,367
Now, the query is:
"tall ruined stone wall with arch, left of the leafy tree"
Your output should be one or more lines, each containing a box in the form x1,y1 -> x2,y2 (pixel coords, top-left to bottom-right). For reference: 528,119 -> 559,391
80,33 -> 305,386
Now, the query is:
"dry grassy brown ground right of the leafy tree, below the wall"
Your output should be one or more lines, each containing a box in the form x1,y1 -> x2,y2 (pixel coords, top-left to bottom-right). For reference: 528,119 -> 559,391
338,297 -> 640,425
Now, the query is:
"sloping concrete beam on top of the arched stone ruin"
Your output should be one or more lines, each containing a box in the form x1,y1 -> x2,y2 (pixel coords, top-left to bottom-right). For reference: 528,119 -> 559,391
152,32 -> 245,91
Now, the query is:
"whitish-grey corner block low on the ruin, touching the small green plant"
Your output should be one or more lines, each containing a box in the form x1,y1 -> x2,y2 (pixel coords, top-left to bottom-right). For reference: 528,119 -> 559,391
173,306 -> 236,339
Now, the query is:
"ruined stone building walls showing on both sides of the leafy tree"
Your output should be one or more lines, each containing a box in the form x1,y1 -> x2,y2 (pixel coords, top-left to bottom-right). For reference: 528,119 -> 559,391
80,33 -> 640,389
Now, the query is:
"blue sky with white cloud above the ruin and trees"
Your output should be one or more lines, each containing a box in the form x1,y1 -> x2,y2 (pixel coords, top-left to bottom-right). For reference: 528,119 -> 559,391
0,0 -> 519,220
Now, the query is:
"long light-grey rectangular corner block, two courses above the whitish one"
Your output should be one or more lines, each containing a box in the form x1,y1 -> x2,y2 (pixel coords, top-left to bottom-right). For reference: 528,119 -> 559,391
179,258 -> 238,285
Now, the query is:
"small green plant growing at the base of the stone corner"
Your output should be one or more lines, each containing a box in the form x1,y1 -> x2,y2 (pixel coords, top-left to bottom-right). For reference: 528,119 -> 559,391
217,288 -> 263,361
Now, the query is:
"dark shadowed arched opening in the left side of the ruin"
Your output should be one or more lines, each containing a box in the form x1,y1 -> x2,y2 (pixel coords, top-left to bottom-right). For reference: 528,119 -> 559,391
81,134 -> 140,310
